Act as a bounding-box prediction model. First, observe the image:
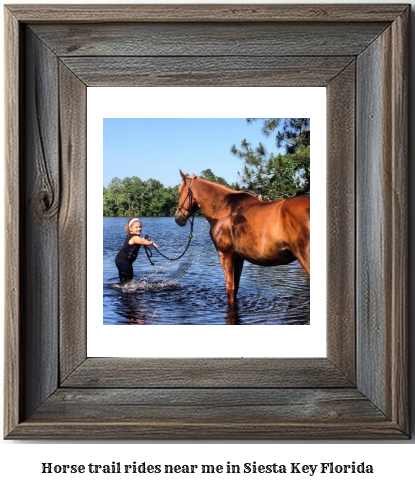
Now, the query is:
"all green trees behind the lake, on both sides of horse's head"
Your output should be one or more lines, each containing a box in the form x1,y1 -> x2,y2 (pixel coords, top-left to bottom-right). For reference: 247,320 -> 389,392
103,119 -> 310,217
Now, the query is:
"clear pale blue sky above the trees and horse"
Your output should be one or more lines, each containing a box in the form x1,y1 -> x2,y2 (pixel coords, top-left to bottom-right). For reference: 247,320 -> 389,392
104,118 -> 277,187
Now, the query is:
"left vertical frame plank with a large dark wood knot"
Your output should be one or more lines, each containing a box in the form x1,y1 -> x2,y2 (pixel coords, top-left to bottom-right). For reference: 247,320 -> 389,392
19,31 -> 61,416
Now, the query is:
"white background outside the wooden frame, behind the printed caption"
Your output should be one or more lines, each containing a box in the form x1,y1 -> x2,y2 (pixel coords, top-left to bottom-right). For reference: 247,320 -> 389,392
0,0 -> 415,488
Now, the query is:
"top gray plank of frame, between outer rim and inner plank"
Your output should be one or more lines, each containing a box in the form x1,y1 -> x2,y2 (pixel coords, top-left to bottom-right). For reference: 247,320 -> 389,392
31,22 -> 388,57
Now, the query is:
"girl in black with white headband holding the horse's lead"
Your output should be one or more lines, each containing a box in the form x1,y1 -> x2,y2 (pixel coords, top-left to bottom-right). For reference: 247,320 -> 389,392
115,217 -> 158,283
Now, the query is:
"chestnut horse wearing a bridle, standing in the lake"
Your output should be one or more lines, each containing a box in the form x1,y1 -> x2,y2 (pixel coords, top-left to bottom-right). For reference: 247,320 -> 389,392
174,170 -> 310,304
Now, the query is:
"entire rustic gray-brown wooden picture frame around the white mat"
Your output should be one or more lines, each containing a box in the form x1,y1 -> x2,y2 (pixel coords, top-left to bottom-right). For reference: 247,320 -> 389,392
4,5 -> 410,439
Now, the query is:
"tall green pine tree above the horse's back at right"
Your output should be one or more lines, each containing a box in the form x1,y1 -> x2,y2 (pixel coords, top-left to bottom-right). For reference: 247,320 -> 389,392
231,119 -> 310,200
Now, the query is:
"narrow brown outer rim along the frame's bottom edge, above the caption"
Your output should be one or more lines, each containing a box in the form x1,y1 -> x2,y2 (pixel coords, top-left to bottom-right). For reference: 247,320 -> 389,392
10,419 -> 406,442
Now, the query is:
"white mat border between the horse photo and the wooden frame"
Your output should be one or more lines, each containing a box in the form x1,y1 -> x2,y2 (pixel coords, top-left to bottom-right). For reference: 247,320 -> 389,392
87,87 -> 326,357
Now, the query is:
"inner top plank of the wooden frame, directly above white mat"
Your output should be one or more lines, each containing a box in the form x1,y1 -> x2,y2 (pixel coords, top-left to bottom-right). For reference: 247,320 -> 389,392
61,56 -> 353,86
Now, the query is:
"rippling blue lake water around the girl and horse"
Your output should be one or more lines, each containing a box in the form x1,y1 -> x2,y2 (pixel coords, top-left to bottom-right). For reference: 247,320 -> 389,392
103,217 -> 310,325
